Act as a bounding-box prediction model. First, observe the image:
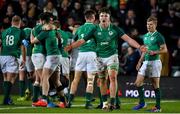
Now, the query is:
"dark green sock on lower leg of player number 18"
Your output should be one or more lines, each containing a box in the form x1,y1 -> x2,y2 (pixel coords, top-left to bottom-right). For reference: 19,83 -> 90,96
4,81 -> 12,99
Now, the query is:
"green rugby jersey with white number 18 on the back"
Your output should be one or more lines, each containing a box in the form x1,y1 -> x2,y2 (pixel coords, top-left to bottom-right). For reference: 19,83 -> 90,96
1,26 -> 25,58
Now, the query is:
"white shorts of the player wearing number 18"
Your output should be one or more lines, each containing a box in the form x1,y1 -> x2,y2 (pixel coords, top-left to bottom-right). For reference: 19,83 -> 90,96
0,56 -> 19,73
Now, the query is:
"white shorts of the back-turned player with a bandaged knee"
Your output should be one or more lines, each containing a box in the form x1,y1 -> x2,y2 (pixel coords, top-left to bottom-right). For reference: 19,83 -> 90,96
75,52 -> 98,72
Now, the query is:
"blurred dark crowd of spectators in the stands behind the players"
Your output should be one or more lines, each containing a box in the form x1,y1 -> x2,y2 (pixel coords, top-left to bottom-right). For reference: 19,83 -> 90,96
0,0 -> 180,77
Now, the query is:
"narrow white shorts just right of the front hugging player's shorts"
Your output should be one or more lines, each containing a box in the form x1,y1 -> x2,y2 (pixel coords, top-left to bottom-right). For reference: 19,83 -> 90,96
60,56 -> 70,74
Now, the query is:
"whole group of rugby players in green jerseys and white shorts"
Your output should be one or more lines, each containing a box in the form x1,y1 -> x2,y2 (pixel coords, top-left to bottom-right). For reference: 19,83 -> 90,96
0,8 -> 167,112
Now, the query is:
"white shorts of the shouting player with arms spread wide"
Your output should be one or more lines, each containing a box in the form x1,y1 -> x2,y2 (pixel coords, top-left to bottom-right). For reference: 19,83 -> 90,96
98,54 -> 119,71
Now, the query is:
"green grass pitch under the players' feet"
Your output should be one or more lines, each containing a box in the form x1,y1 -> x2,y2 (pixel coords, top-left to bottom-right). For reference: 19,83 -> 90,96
0,96 -> 180,114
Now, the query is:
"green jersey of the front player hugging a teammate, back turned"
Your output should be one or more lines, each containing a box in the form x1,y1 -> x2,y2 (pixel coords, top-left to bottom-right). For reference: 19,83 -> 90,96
37,30 -> 60,55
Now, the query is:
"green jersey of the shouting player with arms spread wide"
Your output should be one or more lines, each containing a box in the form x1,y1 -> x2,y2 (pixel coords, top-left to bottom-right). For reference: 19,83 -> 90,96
94,24 -> 125,58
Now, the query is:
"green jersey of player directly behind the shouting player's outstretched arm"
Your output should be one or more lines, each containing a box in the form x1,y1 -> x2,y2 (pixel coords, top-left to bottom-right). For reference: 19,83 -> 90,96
75,22 -> 96,52
